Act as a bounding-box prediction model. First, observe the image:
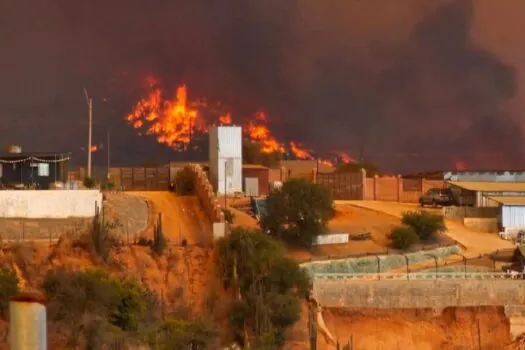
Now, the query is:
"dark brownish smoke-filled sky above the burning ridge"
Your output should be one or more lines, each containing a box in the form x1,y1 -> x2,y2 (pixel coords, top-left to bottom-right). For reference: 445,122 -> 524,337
0,0 -> 525,172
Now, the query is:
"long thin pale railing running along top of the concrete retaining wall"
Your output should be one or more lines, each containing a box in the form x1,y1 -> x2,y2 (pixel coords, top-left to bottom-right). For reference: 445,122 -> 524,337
313,271 -> 525,282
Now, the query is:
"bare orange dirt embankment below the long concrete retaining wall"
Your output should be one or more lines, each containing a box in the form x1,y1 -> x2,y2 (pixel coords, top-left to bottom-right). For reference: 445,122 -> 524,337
286,307 -> 524,350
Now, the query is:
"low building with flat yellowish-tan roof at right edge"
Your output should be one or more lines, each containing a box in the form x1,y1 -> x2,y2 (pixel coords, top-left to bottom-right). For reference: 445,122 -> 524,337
447,181 -> 525,207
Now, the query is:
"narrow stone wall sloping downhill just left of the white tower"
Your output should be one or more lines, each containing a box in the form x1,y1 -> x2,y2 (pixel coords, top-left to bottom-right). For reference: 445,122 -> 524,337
184,164 -> 224,223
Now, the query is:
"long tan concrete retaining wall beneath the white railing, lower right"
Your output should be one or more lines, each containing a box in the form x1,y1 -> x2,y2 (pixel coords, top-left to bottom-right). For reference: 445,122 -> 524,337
313,280 -> 525,309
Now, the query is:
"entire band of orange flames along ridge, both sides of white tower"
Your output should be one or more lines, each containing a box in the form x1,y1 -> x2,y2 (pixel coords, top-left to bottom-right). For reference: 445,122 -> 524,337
126,77 -> 353,165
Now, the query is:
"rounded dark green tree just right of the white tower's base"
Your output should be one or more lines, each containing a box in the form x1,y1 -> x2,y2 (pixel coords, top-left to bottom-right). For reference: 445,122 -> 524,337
261,179 -> 334,246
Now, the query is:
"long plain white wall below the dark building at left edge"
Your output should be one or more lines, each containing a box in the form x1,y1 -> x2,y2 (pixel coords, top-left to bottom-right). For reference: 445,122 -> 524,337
0,190 -> 102,219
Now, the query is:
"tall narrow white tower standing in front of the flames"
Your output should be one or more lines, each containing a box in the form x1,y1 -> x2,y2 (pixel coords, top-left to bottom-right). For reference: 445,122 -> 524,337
209,125 -> 242,194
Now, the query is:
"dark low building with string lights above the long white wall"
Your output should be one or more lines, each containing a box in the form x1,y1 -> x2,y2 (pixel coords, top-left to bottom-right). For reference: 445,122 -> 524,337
0,151 -> 71,189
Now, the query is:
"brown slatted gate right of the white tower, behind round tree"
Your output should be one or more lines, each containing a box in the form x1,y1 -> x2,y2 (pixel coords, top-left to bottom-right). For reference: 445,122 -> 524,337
317,172 -> 364,200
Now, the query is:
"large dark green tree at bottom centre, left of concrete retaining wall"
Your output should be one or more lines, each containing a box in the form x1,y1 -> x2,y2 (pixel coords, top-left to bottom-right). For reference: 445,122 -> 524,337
217,228 -> 311,349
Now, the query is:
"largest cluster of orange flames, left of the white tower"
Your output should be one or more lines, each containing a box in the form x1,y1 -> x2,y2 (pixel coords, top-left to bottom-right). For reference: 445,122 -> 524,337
126,78 -> 206,149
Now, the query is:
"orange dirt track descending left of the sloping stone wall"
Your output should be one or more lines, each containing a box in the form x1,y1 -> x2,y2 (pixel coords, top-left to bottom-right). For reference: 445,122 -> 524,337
128,191 -> 213,244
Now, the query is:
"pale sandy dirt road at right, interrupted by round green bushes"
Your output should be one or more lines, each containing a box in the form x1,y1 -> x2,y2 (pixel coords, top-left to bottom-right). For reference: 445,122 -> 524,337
337,201 -> 514,257
